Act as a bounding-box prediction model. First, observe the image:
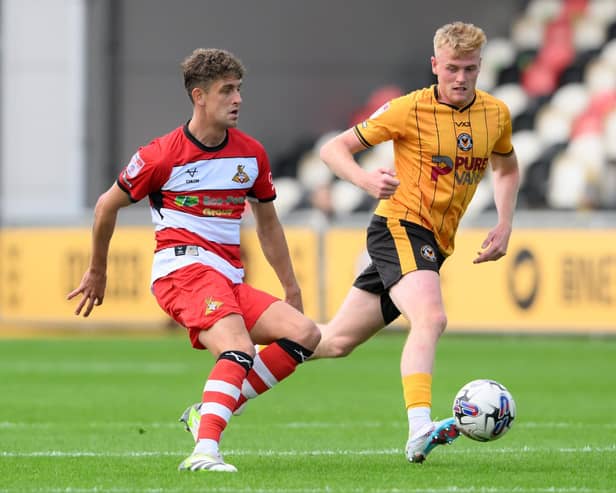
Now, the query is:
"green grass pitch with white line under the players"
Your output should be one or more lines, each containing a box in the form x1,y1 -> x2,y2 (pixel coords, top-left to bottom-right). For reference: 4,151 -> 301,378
0,333 -> 616,493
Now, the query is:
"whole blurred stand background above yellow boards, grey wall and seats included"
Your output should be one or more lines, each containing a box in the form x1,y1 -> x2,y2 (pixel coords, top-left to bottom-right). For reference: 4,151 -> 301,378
0,0 -> 616,226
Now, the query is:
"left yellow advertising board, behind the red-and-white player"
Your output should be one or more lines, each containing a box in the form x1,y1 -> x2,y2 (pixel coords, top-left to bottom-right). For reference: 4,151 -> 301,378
0,226 -> 320,329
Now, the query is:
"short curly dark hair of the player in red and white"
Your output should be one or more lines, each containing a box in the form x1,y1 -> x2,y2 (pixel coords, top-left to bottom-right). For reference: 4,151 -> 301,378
181,48 -> 245,102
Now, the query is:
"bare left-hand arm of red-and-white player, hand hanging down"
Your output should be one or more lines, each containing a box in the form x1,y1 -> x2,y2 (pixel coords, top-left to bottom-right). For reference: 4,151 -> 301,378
67,183 -> 131,317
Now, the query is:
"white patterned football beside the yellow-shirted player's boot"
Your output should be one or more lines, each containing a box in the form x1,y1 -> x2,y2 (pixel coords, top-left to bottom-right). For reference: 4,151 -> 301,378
453,379 -> 516,442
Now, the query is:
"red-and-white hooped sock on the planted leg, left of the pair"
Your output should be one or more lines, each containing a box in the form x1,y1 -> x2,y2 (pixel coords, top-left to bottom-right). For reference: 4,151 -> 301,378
195,351 -> 253,454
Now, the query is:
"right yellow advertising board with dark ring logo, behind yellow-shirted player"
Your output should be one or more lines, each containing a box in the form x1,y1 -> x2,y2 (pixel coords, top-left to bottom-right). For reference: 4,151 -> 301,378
324,229 -> 616,333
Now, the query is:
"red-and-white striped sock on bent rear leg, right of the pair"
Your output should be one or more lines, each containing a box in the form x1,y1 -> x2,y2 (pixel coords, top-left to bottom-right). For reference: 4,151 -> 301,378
237,339 -> 312,407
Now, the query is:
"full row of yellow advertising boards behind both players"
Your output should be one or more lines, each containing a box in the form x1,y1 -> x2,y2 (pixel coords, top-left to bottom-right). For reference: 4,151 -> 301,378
0,226 -> 616,333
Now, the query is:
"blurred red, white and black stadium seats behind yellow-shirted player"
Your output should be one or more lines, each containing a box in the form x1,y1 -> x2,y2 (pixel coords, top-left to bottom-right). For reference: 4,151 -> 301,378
274,0 -> 616,225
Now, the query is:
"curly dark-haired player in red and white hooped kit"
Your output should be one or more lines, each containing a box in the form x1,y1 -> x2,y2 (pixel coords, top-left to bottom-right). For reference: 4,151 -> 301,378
68,49 -> 320,472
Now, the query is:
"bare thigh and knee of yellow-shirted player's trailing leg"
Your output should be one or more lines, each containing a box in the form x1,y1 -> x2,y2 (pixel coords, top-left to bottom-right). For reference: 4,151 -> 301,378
319,286 -> 385,352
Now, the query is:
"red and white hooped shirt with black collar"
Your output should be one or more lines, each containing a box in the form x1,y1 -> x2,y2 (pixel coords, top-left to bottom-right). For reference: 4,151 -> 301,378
117,124 -> 276,283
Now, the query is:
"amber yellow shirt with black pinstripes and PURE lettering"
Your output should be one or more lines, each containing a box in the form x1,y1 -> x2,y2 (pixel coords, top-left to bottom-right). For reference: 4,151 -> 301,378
353,85 -> 513,255
